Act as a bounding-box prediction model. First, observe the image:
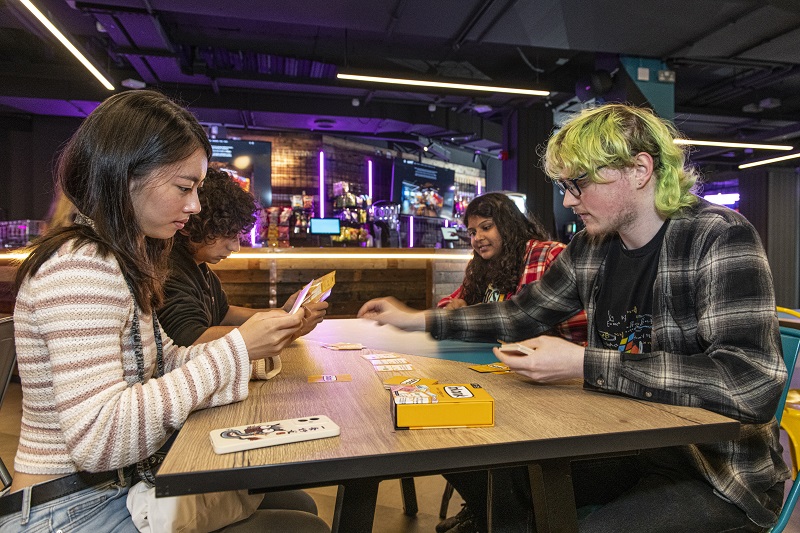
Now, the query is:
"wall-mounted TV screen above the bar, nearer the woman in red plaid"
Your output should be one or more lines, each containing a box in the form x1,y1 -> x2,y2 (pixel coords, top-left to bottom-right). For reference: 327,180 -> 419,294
392,159 -> 456,219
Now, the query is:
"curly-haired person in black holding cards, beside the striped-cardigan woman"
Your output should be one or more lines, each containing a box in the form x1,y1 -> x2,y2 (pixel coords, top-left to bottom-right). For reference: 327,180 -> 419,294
158,167 -> 328,350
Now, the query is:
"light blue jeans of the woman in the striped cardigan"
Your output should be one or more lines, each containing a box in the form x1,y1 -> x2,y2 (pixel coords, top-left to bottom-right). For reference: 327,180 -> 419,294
0,481 -> 136,533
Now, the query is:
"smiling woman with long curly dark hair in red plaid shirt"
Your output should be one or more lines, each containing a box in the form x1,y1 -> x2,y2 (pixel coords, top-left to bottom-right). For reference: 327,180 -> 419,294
438,192 -> 586,343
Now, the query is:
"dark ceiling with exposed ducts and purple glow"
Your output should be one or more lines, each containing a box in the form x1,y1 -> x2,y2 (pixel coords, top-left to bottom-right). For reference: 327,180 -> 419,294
0,0 -> 800,170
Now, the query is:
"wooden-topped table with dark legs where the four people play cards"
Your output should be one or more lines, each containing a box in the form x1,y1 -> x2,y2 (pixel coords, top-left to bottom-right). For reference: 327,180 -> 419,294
156,319 -> 739,533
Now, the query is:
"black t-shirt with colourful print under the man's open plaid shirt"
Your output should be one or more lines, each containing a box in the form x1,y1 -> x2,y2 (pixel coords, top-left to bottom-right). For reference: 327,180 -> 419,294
595,221 -> 669,353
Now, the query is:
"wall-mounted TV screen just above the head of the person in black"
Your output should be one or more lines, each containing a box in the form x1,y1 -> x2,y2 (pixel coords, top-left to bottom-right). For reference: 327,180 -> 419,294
209,139 -> 272,207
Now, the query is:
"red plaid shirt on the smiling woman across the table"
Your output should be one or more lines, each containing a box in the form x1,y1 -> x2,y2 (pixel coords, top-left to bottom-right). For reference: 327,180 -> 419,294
437,239 -> 586,346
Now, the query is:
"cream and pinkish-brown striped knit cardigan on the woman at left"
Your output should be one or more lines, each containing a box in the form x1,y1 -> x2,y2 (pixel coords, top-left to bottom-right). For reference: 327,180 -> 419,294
14,243 -> 250,474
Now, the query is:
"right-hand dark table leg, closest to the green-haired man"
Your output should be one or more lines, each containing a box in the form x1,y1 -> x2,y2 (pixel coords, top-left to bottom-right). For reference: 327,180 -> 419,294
528,459 -> 578,533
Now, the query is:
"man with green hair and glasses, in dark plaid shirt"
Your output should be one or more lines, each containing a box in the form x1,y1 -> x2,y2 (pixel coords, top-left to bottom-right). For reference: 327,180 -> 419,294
359,104 -> 789,533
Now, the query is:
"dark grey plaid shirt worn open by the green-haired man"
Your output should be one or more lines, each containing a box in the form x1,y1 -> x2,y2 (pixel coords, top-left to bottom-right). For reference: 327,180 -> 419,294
427,200 -> 789,527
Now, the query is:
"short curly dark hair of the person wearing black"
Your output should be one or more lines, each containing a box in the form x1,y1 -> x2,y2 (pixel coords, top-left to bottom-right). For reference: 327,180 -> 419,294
183,167 -> 257,244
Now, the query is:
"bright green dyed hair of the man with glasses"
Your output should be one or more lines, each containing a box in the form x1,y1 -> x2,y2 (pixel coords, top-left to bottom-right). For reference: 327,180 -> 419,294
544,104 -> 698,217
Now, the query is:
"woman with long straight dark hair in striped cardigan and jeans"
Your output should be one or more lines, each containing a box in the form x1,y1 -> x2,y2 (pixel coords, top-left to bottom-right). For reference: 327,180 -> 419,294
0,91 -> 324,533
